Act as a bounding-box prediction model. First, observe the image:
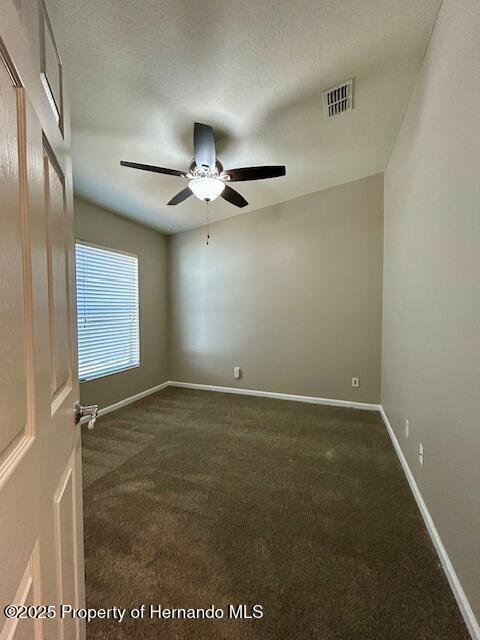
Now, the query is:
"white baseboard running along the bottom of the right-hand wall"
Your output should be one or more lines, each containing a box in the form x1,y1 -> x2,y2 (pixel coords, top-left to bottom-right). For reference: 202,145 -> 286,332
380,407 -> 480,640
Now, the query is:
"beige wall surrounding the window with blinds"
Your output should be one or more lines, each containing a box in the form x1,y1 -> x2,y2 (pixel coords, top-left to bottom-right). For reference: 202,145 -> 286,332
75,198 -> 168,407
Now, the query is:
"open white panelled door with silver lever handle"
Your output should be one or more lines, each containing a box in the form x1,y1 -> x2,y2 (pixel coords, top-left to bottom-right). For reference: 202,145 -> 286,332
0,0 -> 85,640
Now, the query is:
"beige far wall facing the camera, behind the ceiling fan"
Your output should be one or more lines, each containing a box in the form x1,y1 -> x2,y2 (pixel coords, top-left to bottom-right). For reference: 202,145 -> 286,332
169,175 -> 383,403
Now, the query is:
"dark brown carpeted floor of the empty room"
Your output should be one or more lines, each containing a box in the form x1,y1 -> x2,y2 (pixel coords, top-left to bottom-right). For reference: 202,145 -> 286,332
83,388 -> 469,640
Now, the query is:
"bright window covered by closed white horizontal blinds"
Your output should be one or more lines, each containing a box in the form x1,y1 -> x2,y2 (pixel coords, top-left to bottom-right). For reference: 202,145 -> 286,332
76,242 -> 140,381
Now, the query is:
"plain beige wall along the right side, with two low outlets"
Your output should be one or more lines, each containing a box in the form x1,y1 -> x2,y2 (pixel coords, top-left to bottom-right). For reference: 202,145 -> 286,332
382,0 -> 480,618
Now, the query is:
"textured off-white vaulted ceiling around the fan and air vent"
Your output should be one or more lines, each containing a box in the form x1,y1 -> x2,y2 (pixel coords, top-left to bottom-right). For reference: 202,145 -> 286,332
48,0 -> 440,233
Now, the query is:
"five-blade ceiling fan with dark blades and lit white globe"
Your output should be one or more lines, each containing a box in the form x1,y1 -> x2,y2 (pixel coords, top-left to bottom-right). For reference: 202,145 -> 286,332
120,122 -> 286,207
